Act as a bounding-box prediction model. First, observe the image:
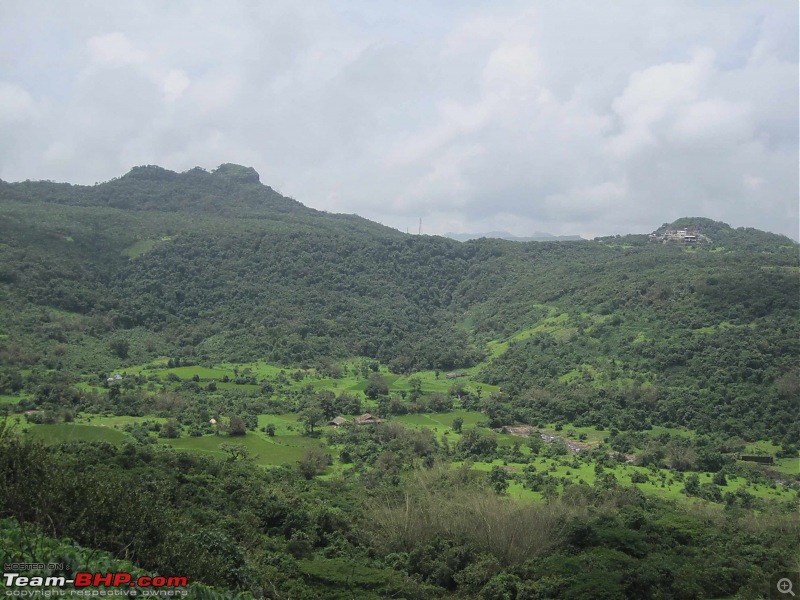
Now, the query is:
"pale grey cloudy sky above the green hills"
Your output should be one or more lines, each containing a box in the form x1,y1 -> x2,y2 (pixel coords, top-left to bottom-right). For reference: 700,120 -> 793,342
0,0 -> 799,238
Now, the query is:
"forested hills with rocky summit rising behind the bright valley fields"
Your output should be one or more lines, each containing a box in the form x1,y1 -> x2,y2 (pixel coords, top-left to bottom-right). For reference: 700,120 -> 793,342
0,165 -> 800,441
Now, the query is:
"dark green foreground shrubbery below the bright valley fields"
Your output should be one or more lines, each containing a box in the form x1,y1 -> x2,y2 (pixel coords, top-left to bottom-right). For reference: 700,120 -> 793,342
0,428 -> 798,599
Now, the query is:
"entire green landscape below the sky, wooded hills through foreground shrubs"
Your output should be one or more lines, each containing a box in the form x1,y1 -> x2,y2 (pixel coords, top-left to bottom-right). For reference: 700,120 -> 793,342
0,164 -> 800,599
